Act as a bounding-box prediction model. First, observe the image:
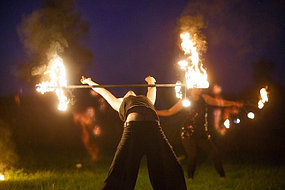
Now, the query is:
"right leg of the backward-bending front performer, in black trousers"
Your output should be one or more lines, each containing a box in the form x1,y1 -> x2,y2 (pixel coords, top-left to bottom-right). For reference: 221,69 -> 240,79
146,122 -> 187,190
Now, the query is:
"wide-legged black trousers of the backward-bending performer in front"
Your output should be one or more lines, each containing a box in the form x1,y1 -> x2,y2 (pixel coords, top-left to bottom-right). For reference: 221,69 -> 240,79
103,121 -> 187,190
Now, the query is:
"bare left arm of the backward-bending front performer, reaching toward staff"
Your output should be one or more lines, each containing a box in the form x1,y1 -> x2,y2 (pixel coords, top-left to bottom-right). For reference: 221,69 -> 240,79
80,76 -> 122,112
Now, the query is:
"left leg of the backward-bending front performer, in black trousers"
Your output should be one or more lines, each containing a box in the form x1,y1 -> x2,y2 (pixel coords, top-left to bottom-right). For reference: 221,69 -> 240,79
102,125 -> 143,190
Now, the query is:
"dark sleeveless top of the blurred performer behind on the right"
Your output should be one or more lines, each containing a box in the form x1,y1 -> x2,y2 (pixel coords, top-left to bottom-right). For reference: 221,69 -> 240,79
184,95 -> 208,132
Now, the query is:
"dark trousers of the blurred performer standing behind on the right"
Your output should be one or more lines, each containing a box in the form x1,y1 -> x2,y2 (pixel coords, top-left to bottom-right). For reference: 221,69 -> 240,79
182,133 -> 225,178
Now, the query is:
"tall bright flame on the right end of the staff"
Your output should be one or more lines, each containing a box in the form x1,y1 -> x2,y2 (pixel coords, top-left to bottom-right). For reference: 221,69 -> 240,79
178,32 -> 209,88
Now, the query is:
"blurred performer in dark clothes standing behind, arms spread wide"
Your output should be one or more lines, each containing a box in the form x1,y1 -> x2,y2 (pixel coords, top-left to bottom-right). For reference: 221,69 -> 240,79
157,88 -> 242,180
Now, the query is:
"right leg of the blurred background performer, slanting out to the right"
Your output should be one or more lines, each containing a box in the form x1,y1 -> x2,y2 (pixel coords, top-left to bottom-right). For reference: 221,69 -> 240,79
199,137 -> 225,177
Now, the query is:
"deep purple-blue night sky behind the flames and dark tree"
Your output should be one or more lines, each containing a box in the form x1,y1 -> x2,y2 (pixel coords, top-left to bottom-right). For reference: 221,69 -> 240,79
0,0 -> 285,95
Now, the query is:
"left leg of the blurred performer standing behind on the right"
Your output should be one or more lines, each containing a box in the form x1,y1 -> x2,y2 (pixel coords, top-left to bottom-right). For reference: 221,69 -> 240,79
182,136 -> 196,179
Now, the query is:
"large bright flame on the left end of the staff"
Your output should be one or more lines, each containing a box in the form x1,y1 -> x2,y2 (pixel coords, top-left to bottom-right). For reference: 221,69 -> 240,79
36,55 -> 69,111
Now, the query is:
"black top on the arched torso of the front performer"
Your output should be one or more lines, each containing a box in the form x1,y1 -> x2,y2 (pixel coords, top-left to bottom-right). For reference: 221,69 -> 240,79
119,95 -> 157,121
